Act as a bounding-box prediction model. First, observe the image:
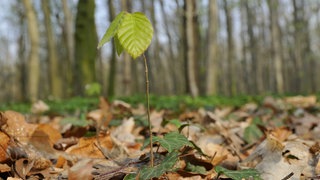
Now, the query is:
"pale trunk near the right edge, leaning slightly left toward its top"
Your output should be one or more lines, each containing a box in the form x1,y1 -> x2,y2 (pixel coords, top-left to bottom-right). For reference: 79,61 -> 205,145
267,0 -> 284,94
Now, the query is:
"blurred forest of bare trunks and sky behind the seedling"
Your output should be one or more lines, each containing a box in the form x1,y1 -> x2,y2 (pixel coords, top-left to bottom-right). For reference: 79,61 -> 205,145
0,0 -> 320,102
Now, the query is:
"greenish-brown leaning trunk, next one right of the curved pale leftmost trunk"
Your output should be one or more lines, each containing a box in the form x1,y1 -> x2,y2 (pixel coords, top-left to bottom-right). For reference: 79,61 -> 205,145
41,1 -> 62,98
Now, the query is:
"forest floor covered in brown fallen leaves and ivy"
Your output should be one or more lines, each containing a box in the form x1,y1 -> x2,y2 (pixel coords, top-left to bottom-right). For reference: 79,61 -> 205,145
0,96 -> 320,180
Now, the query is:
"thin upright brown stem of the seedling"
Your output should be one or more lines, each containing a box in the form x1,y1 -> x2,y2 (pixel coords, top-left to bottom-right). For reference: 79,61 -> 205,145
142,54 -> 153,167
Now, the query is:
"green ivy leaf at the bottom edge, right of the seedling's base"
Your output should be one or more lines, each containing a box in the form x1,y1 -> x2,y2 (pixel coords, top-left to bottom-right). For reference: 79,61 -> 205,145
214,166 -> 261,180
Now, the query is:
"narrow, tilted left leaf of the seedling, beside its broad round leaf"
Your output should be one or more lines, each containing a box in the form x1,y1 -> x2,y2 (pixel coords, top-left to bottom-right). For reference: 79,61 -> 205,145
98,11 -> 127,48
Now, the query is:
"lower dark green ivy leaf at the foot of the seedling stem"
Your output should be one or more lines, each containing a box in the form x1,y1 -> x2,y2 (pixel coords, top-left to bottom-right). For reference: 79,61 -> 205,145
140,151 -> 178,179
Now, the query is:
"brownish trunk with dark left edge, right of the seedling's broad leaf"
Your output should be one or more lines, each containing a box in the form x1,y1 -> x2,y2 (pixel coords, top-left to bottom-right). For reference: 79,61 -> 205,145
184,0 -> 199,97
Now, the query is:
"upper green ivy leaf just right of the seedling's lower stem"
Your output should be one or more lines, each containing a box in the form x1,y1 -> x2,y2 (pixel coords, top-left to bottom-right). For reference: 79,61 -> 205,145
153,132 -> 193,153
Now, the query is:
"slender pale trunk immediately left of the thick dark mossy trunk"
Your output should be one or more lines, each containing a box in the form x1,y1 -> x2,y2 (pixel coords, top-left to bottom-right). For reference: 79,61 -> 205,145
61,0 -> 75,96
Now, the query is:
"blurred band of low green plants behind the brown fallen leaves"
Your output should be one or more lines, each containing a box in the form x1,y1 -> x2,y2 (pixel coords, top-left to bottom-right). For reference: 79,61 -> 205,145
0,95 -> 276,113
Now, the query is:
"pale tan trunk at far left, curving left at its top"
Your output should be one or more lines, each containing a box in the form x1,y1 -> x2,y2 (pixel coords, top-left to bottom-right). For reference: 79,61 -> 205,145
22,0 -> 40,102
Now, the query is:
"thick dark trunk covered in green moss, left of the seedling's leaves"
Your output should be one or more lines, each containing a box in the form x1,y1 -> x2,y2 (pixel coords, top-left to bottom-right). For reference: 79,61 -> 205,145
75,0 -> 98,95
